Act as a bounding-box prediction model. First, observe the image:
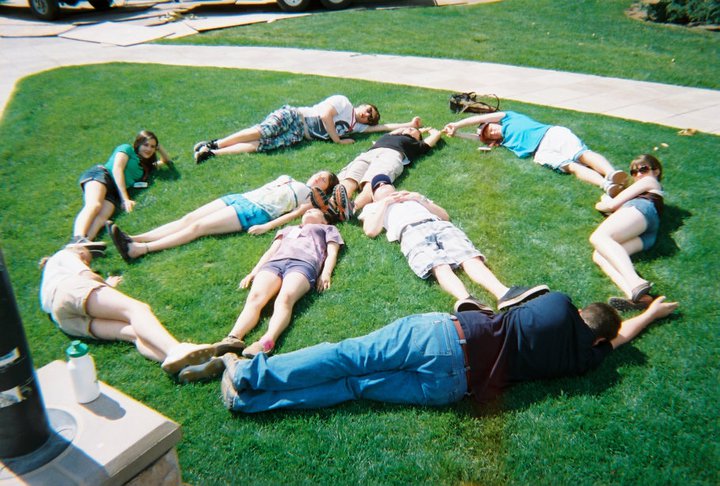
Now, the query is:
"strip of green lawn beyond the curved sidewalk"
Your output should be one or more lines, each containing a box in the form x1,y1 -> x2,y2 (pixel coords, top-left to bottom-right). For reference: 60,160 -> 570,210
164,0 -> 720,89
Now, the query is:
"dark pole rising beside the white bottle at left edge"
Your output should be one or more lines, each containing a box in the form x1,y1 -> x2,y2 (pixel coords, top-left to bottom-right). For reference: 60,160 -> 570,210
0,249 -> 52,458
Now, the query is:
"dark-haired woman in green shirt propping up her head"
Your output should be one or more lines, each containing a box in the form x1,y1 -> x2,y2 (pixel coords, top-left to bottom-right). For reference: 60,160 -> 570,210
70,130 -> 171,253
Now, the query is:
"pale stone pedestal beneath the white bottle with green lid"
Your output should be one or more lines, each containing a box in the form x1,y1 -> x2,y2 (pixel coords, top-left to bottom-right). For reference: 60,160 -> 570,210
0,361 -> 181,486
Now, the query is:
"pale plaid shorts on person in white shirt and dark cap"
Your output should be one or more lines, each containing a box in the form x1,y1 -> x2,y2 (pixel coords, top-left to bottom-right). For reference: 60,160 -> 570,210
400,221 -> 485,278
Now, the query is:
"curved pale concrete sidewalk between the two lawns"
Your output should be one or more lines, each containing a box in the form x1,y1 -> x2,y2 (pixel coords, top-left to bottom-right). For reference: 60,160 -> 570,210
0,37 -> 720,135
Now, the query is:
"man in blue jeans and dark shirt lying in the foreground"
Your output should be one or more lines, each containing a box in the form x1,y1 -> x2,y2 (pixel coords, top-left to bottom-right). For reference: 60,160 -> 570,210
221,292 -> 677,413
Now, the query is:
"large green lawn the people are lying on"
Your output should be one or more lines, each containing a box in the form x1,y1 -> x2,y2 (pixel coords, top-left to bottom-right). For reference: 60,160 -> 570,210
0,63 -> 720,484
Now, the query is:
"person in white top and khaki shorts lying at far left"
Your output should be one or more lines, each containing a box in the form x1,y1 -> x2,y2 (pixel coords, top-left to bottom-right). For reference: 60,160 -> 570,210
40,247 -> 215,375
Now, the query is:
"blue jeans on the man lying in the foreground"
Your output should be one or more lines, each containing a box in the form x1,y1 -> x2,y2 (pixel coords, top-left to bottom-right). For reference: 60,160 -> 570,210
231,313 -> 467,413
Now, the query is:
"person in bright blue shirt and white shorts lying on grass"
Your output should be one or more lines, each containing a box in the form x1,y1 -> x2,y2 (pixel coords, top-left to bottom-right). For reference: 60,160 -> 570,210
445,111 -> 627,197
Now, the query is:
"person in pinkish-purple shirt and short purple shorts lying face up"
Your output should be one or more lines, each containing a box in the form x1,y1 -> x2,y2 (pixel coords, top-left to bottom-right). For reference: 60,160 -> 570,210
179,208 -> 344,381
